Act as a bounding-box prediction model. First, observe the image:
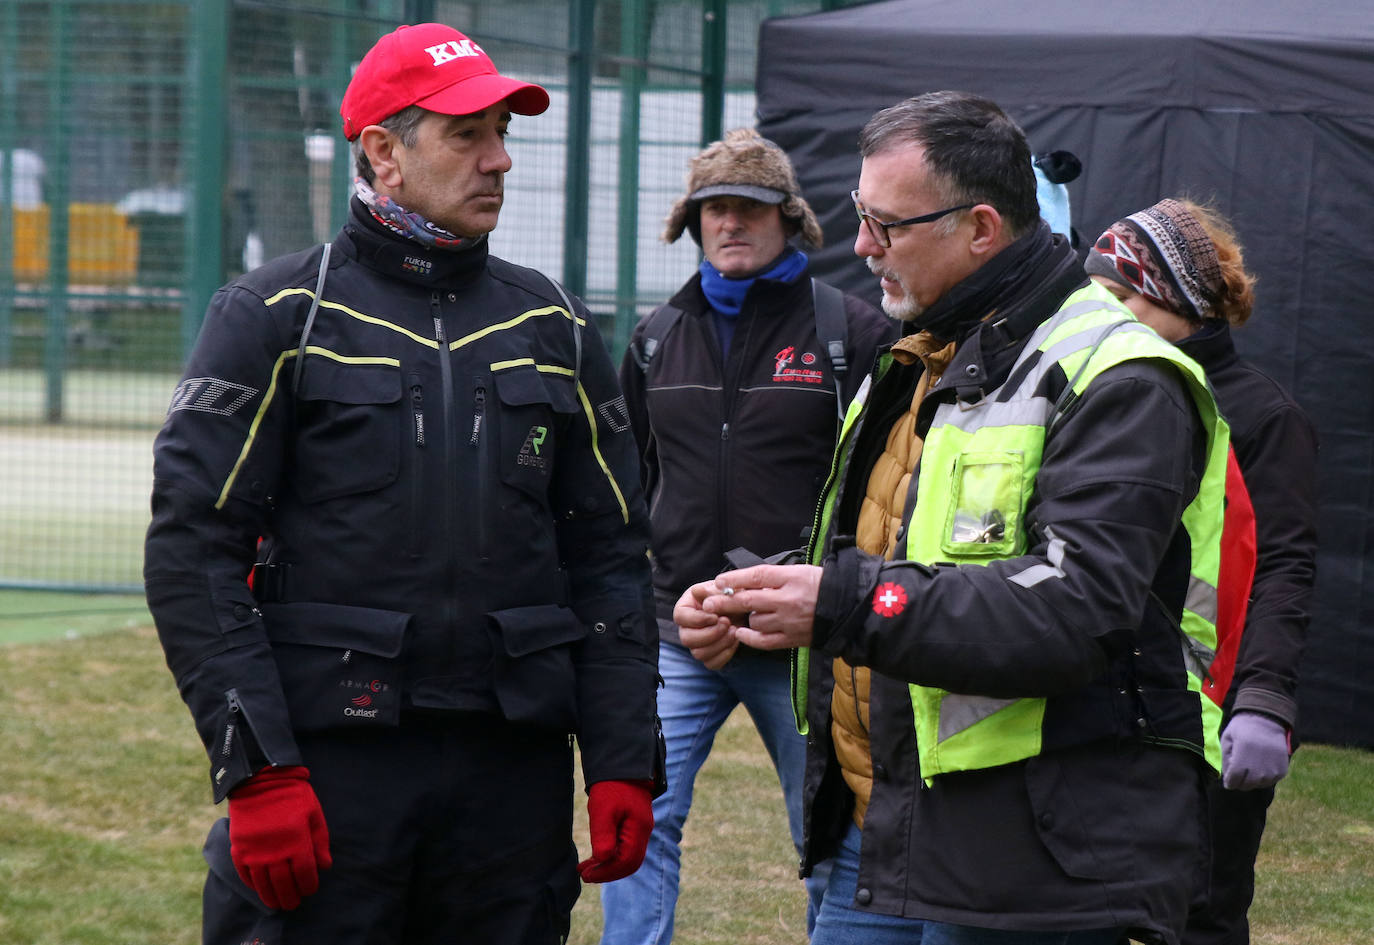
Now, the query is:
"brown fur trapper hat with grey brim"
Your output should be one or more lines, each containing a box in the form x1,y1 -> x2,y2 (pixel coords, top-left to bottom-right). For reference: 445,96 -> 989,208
664,128 -> 823,249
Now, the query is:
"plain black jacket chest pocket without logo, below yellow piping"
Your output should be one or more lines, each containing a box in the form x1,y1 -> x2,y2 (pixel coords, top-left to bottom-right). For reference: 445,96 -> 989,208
294,356 -> 407,503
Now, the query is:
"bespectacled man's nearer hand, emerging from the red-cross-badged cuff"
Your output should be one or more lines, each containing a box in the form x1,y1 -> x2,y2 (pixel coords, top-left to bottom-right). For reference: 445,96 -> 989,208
694,565 -> 822,650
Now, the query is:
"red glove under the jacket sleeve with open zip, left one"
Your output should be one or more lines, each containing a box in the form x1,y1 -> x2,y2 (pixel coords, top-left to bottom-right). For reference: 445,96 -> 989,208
229,768 -> 334,909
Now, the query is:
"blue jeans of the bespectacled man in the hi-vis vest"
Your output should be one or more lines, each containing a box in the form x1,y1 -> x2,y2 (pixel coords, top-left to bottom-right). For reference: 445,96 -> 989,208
811,824 -> 1125,945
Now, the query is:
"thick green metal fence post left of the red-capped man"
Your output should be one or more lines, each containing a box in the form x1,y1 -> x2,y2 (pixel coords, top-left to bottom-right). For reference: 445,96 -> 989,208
181,0 -> 231,354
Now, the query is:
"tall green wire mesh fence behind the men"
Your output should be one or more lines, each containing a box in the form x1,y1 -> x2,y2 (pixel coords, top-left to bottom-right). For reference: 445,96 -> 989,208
0,0 -> 845,591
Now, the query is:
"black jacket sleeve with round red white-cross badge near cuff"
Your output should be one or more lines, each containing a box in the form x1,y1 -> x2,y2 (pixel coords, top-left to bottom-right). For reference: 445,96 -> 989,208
815,361 -> 1205,698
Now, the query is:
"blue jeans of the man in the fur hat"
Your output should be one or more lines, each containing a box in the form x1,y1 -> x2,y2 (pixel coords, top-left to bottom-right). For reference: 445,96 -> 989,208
602,643 -> 824,945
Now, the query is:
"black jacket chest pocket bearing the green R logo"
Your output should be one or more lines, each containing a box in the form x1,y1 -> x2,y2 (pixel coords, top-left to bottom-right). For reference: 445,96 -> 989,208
495,367 -> 577,497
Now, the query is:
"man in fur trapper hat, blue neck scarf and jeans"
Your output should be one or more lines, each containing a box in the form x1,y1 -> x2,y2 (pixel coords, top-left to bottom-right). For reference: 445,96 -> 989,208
602,129 -> 892,945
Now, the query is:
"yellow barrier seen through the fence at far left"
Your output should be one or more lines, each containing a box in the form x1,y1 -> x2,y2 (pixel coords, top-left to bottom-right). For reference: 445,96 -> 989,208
9,203 -> 139,286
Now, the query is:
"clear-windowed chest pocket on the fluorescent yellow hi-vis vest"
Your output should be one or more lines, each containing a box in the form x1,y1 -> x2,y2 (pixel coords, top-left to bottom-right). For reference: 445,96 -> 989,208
940,449 -> 1025,558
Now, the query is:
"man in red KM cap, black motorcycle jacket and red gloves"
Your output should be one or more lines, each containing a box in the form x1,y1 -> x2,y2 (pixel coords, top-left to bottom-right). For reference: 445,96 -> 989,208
144,23 -> 662,945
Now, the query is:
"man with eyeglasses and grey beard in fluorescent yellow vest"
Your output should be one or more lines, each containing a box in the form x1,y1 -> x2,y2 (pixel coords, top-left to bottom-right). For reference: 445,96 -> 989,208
675,92 -> 1228,945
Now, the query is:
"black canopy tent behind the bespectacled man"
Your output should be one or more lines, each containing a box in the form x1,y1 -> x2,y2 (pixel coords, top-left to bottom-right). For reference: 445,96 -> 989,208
757,0 -> 1374,747
